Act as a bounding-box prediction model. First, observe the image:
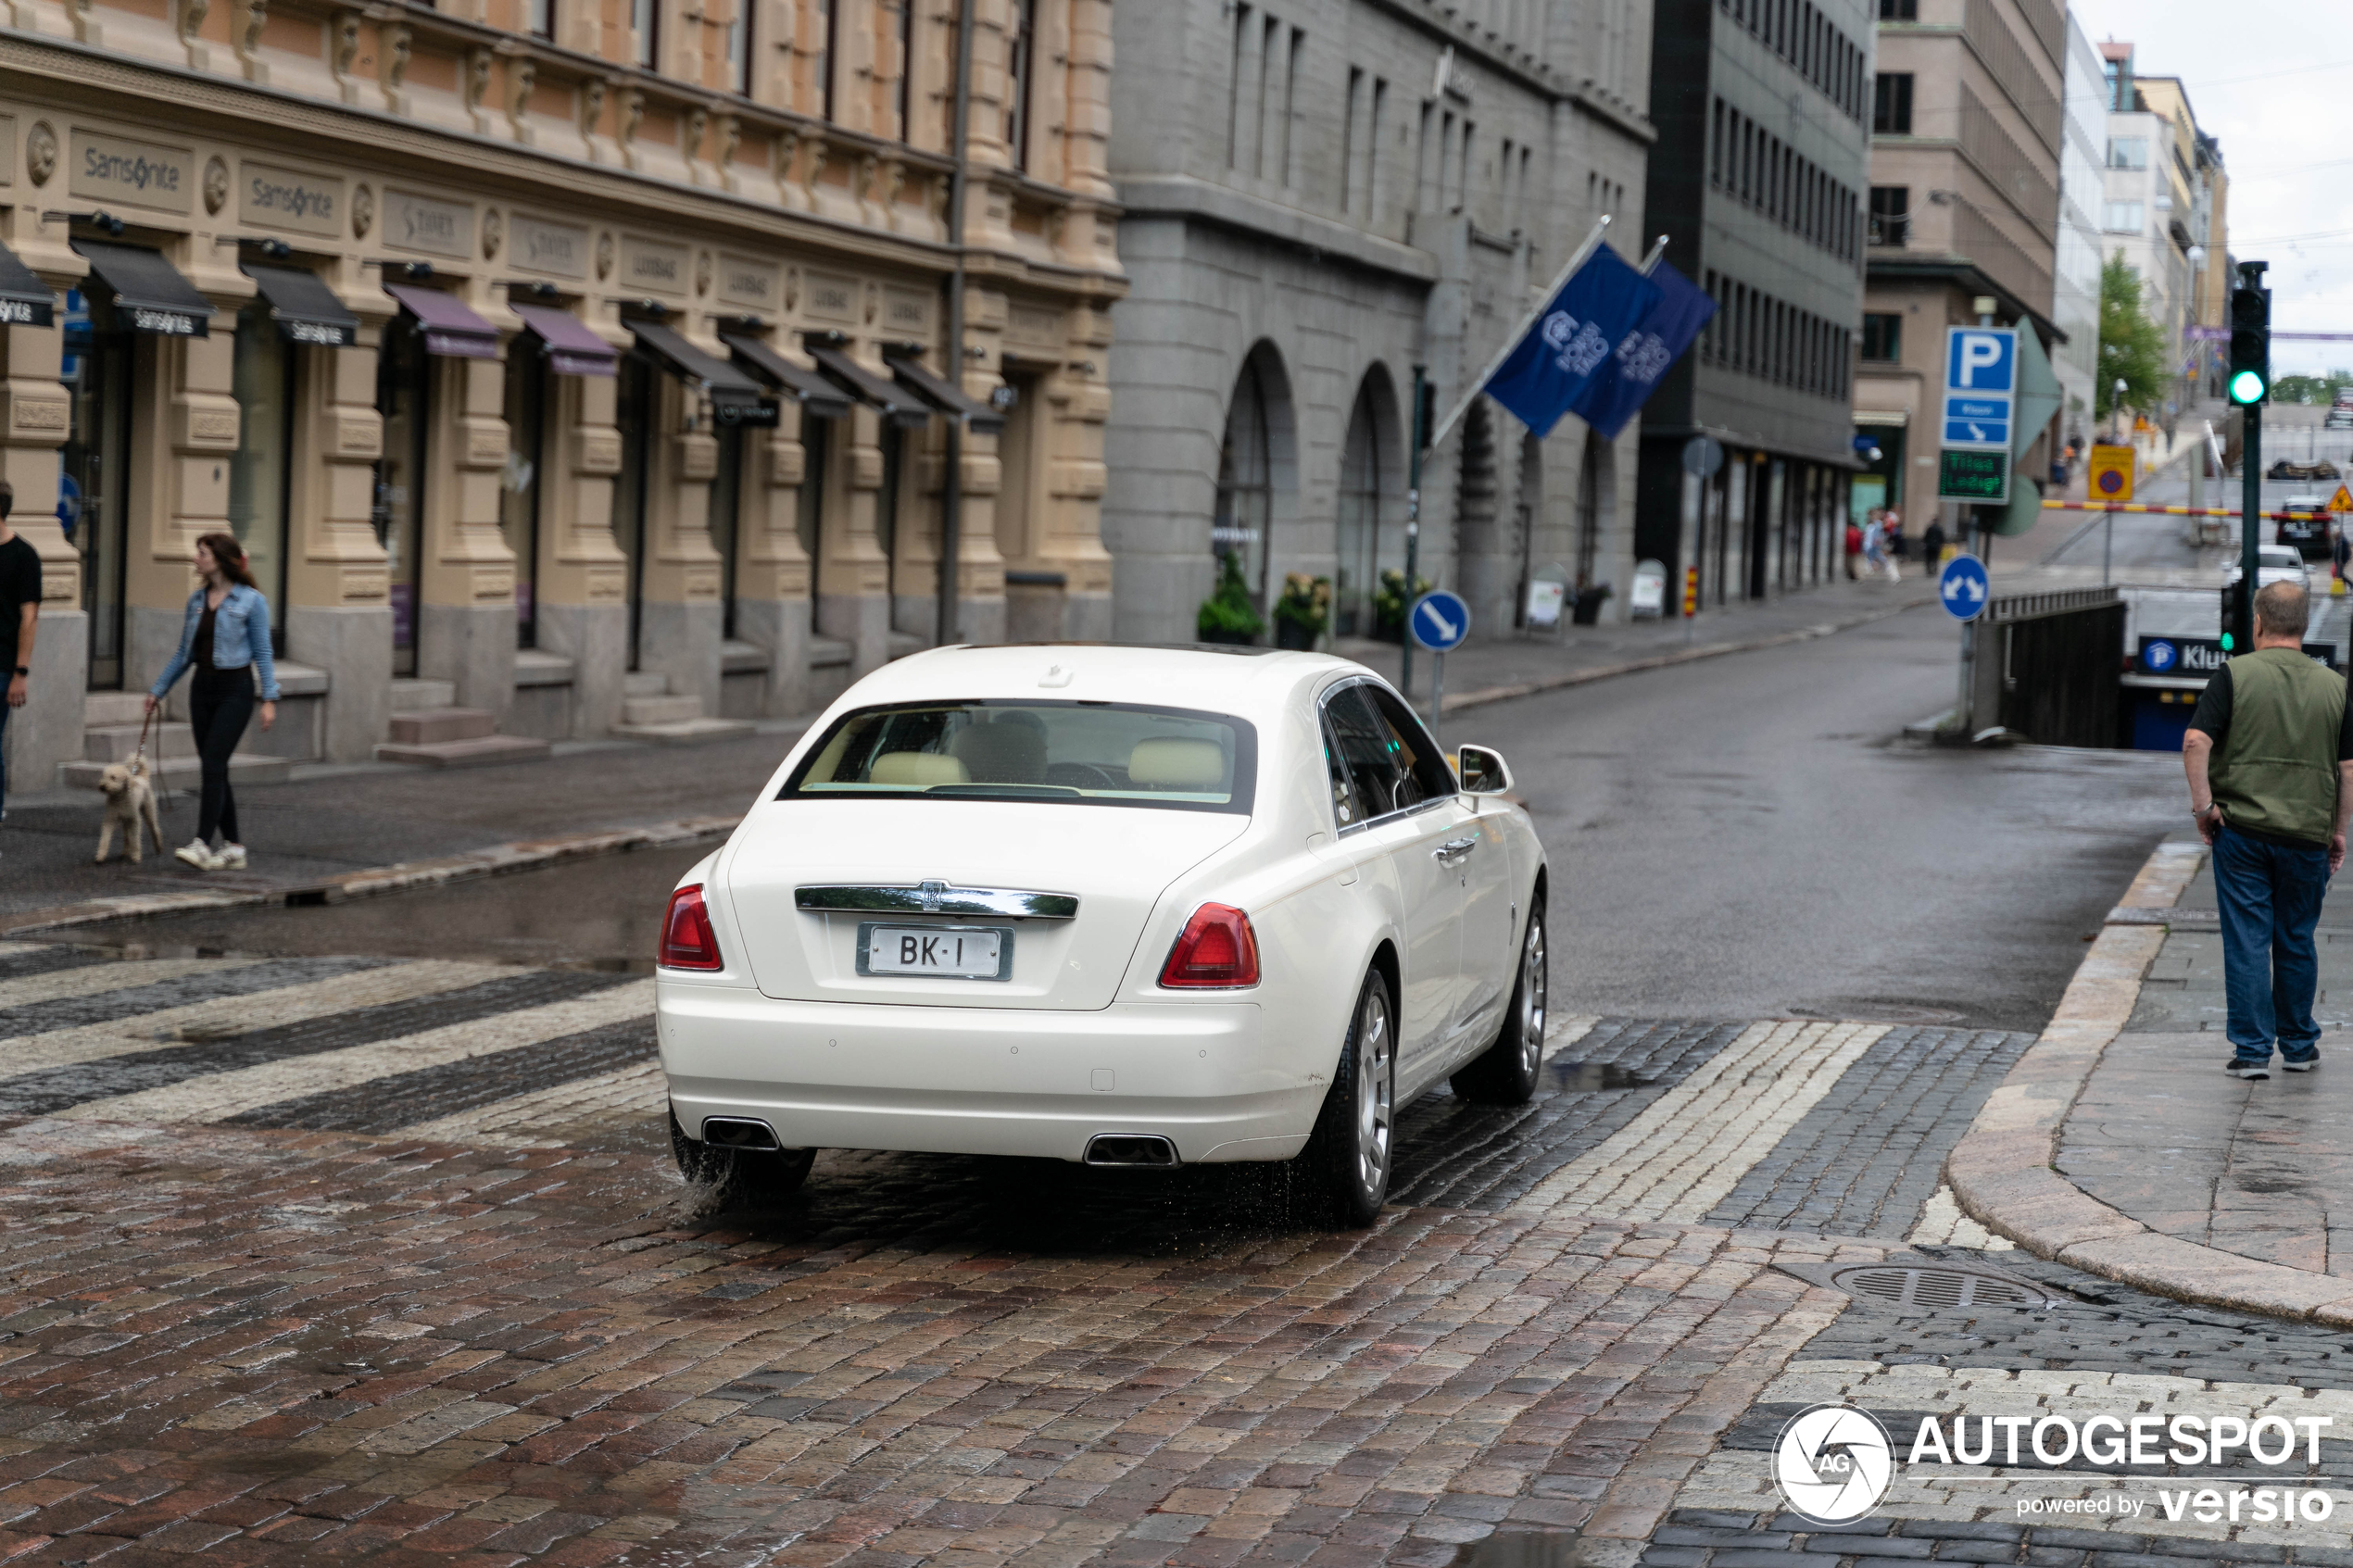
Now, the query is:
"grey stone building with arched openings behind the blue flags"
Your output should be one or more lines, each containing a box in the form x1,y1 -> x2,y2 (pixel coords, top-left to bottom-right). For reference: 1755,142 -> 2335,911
1103,0 -> 1652,642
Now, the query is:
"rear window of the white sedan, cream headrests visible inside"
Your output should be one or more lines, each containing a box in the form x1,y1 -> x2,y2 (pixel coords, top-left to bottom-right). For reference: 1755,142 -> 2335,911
776,700 -> 1259,816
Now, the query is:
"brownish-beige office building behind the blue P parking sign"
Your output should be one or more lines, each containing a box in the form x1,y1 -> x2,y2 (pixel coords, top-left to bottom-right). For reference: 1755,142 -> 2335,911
1855,0 -> 2066,536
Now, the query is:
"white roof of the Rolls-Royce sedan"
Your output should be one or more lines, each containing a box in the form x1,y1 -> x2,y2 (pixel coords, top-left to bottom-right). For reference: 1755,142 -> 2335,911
837,642 -> 1372,724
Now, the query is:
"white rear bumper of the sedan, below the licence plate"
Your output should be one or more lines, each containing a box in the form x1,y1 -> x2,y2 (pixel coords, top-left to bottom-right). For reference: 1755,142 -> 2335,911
657,975 -> 1329,1163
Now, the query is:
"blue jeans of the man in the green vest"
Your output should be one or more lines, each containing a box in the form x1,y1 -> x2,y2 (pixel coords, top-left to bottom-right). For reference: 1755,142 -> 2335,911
2214,827 -> 2330,1062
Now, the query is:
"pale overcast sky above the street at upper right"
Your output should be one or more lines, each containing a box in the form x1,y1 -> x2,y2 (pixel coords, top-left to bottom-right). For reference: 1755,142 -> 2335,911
2073,0 -> 2353,376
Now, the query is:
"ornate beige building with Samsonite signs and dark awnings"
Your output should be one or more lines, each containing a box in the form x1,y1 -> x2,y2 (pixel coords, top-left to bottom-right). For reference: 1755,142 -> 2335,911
0,0 -> 1123,787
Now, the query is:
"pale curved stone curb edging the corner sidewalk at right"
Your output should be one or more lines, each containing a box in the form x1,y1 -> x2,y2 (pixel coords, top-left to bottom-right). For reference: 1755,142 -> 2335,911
1944,844 -> 2353,1328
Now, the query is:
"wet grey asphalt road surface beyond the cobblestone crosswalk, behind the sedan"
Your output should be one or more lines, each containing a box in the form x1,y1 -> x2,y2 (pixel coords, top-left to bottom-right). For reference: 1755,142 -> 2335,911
61,608 -> 2186,1030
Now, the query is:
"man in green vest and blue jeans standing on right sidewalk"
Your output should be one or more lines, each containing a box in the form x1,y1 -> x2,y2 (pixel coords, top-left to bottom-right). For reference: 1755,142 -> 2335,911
2182,583 -> 2353,1079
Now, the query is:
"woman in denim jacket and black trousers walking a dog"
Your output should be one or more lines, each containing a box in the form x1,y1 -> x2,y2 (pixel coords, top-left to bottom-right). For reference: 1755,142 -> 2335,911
148,533 -> 278,872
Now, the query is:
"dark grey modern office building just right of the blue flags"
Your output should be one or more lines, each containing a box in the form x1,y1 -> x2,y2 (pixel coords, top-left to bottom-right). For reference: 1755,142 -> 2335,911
1635,0 -> 1873,604
